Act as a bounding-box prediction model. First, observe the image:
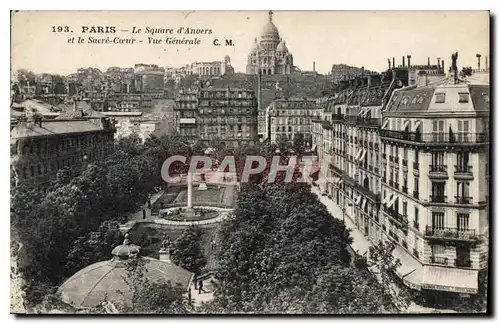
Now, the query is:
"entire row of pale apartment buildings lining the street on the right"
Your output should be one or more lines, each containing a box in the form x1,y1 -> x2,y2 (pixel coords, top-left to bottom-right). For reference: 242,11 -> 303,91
311,58 -> 490,296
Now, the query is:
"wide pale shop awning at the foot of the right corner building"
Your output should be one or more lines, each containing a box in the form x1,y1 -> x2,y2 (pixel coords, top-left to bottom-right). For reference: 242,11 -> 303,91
422,266 -> 478,294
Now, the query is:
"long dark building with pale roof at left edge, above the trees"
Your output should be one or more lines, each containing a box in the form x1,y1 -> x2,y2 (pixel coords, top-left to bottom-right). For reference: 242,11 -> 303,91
10,118 -> 115,184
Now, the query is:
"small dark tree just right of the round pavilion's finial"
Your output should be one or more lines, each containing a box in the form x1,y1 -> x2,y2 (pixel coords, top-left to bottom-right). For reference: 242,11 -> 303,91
170,226 -> 207,275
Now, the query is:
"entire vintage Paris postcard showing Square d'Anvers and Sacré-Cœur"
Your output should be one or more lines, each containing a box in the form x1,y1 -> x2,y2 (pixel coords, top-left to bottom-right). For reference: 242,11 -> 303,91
10,10 -> 491,315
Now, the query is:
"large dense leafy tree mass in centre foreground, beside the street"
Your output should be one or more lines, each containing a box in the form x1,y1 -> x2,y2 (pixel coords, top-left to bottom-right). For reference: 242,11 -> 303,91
209,184 -> 350,312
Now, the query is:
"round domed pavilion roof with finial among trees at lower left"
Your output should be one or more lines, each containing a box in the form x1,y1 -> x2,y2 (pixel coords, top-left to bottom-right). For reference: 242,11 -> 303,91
59,236 -> 194,308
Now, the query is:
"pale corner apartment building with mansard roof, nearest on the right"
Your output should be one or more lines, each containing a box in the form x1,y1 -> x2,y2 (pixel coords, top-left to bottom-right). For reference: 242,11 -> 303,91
380,71 -> 489,294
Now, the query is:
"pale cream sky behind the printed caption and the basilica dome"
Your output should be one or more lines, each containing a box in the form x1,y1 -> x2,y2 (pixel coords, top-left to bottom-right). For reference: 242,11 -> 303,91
11,11 -> 490,75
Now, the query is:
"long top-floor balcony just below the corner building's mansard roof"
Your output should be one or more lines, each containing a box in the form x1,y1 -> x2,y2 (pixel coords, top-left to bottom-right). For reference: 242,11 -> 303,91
380,129 -> 489,144
